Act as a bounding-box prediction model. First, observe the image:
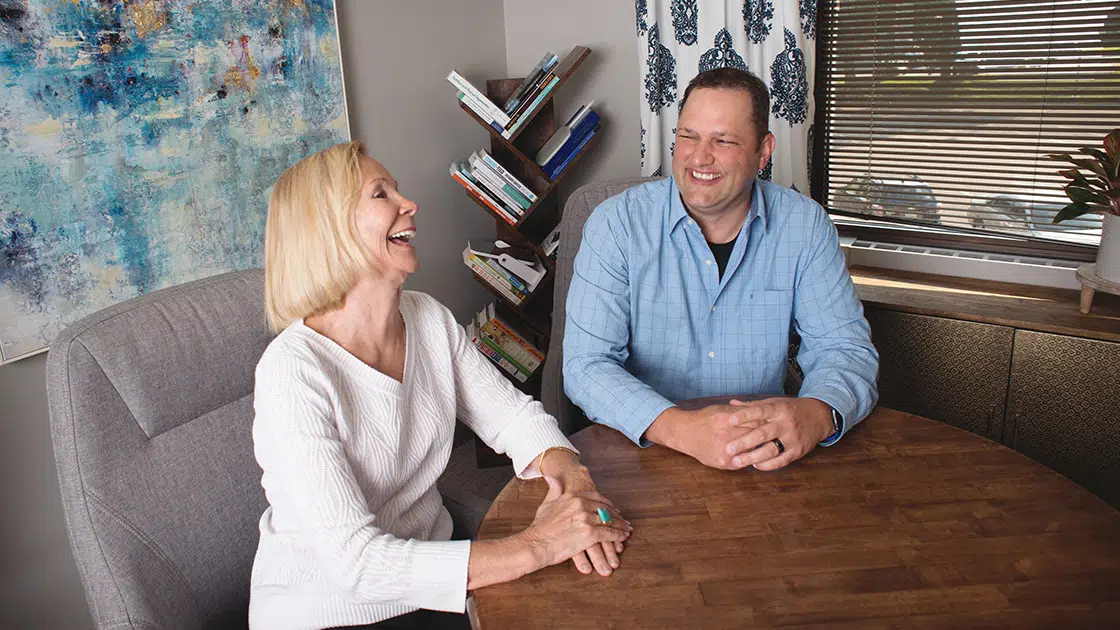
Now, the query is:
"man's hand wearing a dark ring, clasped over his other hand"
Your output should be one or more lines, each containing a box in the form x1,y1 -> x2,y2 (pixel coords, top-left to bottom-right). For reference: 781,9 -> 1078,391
725,398 -> 833,471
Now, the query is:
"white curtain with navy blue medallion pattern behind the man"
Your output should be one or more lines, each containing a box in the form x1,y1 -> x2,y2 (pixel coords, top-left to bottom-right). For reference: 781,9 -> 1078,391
636,0 -> 816,194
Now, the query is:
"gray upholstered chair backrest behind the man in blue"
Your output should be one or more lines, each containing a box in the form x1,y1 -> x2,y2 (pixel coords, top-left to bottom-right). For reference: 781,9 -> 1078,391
541,177 -> 660,434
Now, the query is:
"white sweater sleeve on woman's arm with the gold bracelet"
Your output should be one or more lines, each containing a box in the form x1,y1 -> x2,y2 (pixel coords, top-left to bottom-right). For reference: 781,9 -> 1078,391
440,300 -> 578,479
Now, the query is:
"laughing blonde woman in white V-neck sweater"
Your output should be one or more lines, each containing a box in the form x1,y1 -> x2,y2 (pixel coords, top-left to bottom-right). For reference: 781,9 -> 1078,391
250,142 -> 632,630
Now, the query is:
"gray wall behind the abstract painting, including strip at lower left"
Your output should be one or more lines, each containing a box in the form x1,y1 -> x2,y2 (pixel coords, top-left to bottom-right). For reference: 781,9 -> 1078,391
0,0 -> 505,618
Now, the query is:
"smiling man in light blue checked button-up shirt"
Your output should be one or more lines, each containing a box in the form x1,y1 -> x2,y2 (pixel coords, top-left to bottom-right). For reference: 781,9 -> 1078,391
563,68 -> 879,470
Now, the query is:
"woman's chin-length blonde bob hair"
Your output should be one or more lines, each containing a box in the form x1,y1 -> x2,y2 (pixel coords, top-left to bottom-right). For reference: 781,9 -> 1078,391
264,142 -> 371,333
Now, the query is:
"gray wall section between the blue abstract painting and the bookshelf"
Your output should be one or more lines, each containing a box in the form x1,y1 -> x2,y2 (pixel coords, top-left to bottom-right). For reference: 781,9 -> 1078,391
338,0 -> 505,321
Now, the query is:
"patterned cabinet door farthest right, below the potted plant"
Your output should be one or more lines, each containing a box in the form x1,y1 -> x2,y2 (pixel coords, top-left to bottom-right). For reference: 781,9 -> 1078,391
1004,331 -> 1120,508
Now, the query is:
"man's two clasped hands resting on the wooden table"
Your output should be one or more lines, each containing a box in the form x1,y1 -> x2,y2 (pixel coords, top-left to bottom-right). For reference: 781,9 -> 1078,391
645,398 -> 834,471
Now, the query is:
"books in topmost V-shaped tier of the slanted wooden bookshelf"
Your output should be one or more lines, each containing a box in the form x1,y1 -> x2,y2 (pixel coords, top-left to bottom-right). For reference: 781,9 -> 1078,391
447,46 -> 586,140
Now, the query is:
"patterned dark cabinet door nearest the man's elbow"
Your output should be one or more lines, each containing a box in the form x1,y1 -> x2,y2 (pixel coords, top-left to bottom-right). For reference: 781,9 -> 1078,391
867,307 -> 1015,442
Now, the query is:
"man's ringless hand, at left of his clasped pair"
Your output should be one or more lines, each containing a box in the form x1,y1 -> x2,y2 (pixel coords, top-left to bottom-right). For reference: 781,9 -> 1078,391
645,405 -> 763,470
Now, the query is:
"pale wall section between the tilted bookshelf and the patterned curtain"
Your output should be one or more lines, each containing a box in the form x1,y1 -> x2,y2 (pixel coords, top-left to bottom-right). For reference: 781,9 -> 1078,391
505,0 -> 642,202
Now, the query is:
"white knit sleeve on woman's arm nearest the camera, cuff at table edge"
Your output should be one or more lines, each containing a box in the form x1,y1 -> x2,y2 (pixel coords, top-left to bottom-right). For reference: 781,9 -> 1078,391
253,355 -> 470,612
